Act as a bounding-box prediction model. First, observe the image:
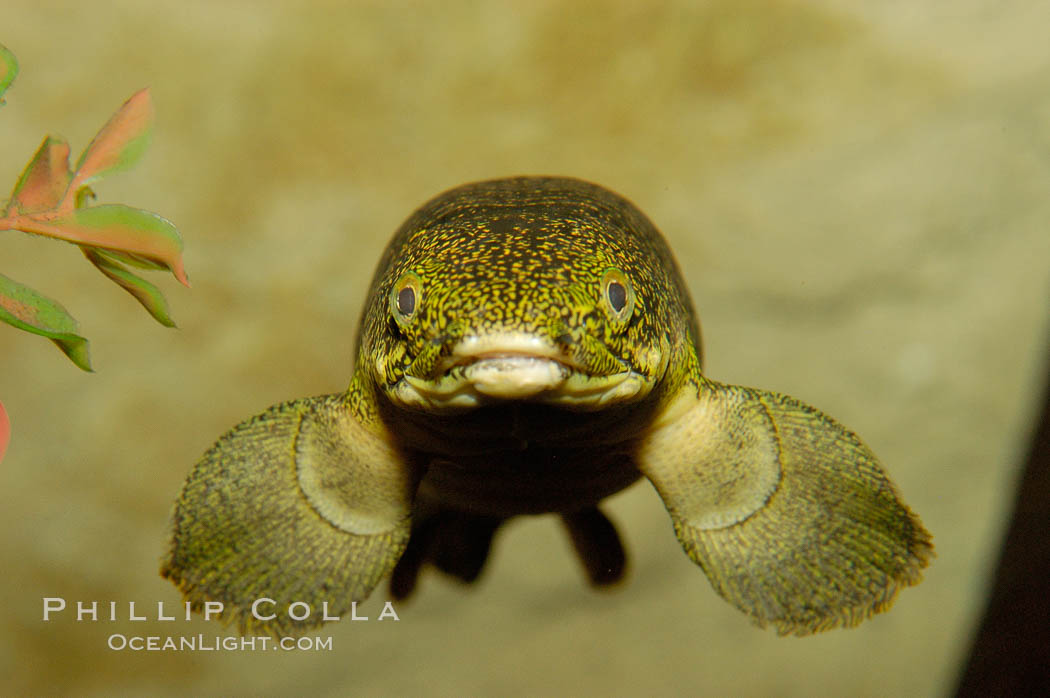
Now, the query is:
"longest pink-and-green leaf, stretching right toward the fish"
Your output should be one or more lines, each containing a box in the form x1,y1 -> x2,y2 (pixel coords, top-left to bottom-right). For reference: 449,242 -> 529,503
14,204 -> 189,285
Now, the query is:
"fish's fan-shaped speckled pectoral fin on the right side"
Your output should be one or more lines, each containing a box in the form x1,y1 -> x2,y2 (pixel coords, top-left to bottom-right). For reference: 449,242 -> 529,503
637,381 -> 932,635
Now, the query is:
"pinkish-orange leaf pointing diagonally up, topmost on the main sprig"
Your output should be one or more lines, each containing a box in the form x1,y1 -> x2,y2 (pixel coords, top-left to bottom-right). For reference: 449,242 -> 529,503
72,88 -> 153,191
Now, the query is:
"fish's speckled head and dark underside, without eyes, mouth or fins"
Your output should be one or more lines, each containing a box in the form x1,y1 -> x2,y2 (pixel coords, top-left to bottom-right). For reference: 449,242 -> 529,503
351,177 -> 700,515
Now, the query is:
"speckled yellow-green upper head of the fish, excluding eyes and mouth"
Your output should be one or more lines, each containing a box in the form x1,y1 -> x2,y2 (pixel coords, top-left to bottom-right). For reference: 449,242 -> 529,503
358,177 -> 699,403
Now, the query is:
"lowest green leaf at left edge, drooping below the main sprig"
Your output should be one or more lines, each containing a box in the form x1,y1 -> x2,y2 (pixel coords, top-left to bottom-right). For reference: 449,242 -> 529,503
0,274 -> 91,371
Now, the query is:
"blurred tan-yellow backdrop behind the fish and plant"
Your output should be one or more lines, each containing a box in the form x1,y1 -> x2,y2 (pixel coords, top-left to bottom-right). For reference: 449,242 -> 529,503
0,0 -> 1050,696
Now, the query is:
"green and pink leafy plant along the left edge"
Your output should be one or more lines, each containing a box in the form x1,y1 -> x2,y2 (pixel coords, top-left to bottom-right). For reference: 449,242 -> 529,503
0,45 -> 189,458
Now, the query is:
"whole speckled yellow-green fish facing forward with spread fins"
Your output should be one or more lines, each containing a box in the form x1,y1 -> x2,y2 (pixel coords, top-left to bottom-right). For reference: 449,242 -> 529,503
162,177 -> 932,635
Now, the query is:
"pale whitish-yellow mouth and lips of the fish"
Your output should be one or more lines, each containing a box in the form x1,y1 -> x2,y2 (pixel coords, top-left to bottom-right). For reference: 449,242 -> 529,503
392,333 -> 649,410
